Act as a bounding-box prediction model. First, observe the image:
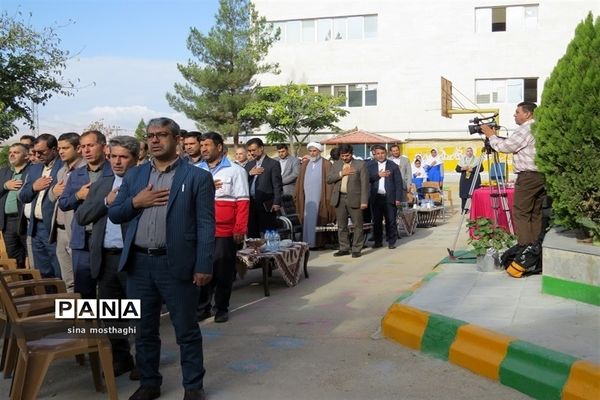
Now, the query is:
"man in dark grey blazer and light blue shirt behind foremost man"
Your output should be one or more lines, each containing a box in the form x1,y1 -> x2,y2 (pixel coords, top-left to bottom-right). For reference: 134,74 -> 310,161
75,136 -> 140,377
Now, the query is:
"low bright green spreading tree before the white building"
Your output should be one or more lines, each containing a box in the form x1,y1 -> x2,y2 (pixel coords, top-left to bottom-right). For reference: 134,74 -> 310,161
240,83 -> 348,154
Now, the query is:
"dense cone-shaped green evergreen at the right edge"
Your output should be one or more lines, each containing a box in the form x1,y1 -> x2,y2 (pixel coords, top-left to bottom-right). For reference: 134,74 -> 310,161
533,13 -> 600,241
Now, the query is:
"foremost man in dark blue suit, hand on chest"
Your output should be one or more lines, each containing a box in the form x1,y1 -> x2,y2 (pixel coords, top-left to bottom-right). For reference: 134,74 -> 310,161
108,118 -> 215,400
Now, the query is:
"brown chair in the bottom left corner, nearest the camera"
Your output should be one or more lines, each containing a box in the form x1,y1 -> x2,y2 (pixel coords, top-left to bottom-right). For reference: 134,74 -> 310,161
0,277 -> 118,400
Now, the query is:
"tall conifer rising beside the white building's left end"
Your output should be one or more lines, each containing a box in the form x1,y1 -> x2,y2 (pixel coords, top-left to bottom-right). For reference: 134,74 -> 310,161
167,0 -> 278,144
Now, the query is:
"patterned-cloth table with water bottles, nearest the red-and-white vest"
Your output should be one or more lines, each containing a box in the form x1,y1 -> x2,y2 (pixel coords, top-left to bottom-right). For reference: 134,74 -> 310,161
237,242 -> 310,296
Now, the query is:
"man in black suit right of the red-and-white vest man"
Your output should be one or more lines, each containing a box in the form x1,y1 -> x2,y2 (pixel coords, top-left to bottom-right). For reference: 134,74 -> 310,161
244,138 -> 283,237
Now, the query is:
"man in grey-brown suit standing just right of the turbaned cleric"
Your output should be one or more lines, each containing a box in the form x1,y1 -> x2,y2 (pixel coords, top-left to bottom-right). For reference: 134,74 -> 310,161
327,144 -> 369,258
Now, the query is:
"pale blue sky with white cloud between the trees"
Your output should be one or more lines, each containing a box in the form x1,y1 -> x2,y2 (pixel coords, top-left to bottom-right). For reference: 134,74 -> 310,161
2,0 -> 218,134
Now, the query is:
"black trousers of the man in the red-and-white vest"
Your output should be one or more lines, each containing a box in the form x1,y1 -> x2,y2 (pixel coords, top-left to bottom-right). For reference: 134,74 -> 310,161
198,237 -> 236,313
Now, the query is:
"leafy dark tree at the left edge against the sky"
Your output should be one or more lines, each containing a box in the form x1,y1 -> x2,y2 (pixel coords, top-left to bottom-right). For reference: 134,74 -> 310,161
0,11 -> 74,139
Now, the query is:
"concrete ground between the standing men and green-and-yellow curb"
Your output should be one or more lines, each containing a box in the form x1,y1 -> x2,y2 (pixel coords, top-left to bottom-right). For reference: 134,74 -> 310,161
0,184 -> 526,400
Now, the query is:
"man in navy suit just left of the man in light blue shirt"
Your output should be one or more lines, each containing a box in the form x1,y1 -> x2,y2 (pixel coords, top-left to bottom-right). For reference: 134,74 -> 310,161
58,130 -> 113,299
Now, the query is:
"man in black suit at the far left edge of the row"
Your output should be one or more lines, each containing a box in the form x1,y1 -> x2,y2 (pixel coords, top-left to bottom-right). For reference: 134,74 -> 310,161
0,143 -> 29,268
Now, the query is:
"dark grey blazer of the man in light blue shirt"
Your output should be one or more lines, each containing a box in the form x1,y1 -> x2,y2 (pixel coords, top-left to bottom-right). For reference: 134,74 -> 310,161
75,175 -> 127,279
